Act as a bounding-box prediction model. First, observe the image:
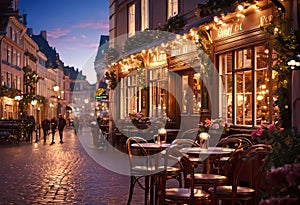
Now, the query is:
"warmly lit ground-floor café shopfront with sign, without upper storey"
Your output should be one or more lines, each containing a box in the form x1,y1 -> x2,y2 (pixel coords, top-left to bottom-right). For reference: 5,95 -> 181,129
111,1 -> 300,134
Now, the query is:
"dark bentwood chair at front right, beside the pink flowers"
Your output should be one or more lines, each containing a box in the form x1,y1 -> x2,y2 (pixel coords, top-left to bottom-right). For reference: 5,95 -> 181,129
208,144 -> 271,205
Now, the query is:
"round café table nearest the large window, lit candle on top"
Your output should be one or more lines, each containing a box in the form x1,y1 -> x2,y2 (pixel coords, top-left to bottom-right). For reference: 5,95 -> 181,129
181,147 -> 235,173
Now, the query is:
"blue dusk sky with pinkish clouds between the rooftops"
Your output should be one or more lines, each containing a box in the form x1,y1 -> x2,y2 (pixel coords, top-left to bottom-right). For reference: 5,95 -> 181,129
19,0 -> 109,83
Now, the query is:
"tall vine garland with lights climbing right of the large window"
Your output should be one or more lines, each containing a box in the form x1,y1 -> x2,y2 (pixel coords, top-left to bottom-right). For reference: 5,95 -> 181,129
262,10 -> 297,128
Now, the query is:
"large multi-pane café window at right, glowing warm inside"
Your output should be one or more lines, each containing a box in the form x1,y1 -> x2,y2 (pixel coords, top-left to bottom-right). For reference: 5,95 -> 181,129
218,45 -> 278,126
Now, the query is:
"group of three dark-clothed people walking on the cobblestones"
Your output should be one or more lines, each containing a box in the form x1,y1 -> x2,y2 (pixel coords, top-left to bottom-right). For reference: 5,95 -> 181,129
43,114 -> 67,145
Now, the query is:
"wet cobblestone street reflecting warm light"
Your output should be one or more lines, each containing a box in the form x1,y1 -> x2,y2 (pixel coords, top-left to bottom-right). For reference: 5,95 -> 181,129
0,128 -> 143,205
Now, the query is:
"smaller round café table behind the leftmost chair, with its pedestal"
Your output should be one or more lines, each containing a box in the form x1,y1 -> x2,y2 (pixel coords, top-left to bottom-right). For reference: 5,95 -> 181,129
131,142 -> 171,204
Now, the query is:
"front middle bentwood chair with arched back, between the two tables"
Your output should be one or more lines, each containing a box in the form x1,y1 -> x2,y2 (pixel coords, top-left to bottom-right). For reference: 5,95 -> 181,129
159,145 -> 210,204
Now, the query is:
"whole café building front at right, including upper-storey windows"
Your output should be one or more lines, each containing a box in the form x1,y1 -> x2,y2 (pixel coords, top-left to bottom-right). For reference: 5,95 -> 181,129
110,0 -> 299,133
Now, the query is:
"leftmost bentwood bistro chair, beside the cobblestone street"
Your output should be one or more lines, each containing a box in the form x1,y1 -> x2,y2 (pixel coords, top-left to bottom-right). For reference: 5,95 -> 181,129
126,137 -> 161,205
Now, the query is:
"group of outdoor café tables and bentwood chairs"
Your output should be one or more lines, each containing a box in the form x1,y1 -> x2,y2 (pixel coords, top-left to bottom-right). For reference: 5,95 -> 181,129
122,122 -> 299,205
